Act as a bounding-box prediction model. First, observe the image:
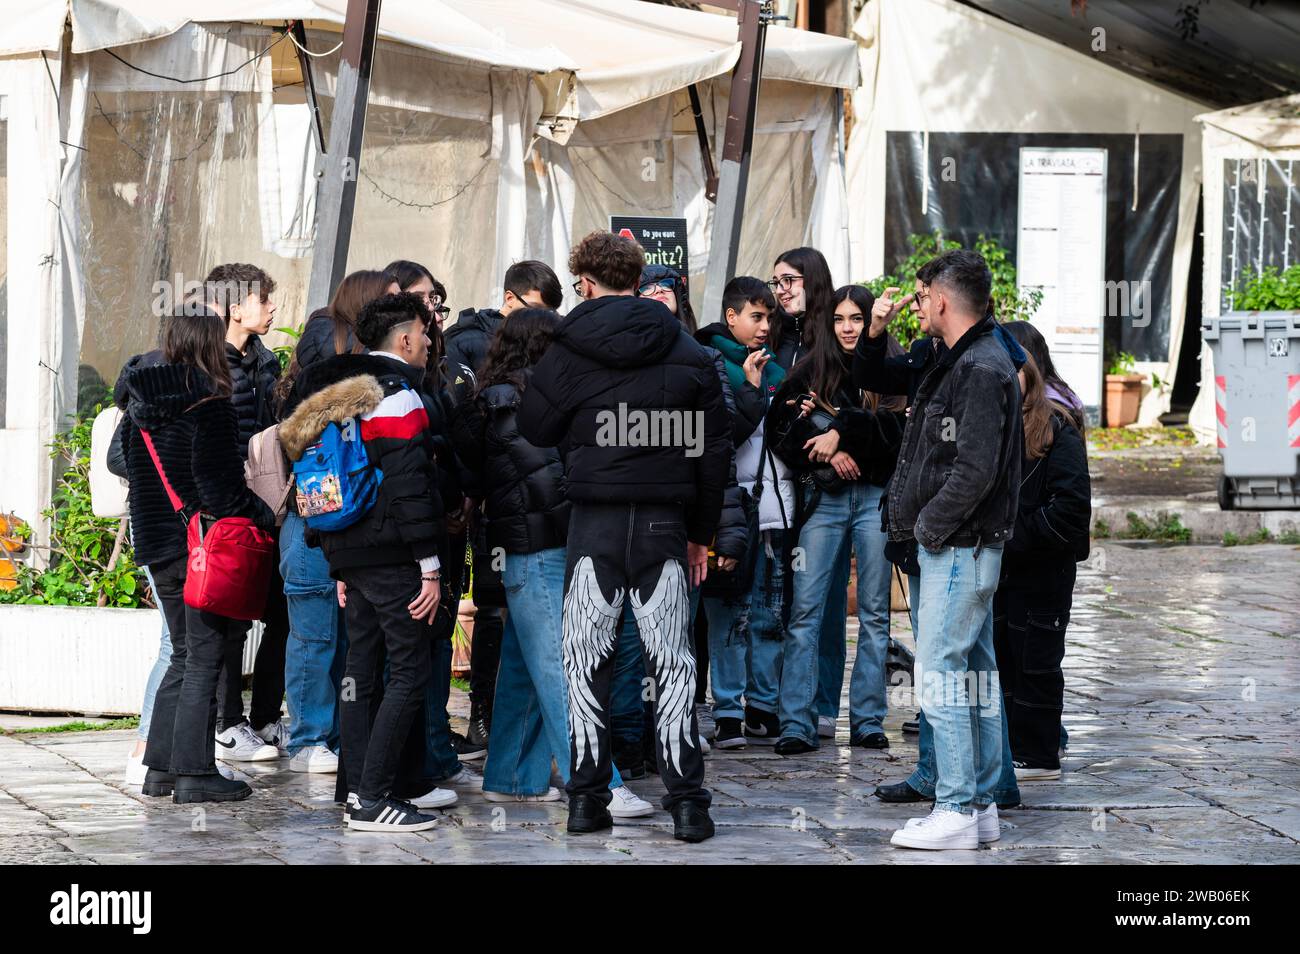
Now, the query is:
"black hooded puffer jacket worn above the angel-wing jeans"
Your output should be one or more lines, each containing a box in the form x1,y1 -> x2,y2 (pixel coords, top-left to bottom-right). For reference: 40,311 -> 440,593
519,295 -> 732,546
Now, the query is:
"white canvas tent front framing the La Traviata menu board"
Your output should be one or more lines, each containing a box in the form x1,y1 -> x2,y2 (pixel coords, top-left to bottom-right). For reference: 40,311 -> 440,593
848,0 -> 1204,424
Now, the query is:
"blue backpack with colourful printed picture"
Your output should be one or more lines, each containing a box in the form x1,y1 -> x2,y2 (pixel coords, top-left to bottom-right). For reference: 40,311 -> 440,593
294,417 -> 384,530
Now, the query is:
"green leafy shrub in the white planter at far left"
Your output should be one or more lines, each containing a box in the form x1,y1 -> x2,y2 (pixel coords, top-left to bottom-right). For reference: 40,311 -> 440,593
0,404 -> 146,607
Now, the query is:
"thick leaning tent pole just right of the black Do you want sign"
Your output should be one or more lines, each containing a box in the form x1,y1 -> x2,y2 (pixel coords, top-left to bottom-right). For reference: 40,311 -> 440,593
701,0 -> 772,322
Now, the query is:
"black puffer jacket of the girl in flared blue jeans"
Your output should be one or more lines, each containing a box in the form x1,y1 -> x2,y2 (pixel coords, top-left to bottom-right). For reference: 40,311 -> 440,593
452,372 -> 569,554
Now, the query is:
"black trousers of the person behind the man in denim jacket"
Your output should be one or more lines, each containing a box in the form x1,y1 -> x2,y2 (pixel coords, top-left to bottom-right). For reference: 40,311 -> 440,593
993,556 -> 1075,768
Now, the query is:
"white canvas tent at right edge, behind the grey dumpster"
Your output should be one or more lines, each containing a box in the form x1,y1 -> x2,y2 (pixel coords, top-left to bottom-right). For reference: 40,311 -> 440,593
1190,94 -> 1300,445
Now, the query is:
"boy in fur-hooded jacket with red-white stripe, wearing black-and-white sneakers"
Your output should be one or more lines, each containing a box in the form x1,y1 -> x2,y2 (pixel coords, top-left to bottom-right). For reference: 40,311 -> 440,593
280,294 -> 446,832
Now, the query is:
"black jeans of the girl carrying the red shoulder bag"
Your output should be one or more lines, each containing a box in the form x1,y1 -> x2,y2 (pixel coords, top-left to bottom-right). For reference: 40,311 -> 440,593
144,556 -> 248,775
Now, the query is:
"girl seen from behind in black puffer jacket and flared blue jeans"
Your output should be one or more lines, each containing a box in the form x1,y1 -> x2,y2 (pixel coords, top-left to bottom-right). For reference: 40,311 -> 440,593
454,308 -> 654,818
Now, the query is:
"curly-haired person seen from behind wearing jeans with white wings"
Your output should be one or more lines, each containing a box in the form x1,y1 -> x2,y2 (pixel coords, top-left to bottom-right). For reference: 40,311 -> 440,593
519,231 -> 732,841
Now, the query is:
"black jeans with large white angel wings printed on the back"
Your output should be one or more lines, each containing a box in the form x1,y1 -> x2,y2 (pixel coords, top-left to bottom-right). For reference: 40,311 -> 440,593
564,502 -> 710,808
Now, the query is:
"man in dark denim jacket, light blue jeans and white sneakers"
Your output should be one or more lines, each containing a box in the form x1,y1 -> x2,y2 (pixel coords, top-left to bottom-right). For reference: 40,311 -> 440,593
887,250 -> 1022,849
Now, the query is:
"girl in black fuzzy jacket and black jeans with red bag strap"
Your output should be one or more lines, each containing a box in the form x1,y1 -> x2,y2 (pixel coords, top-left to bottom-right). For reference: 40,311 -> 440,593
118,311 -> 276,802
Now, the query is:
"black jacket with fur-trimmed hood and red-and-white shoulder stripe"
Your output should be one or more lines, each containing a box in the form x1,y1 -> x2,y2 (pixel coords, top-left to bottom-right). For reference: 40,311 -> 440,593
280,355 -> 446,576
